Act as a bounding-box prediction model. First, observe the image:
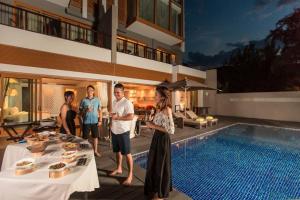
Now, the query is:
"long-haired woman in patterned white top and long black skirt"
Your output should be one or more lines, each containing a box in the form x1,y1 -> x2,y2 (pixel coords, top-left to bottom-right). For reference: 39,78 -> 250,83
144,87 -> 175,199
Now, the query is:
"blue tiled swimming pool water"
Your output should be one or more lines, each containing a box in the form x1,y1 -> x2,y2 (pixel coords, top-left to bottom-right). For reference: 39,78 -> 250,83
135,124 -> 300,200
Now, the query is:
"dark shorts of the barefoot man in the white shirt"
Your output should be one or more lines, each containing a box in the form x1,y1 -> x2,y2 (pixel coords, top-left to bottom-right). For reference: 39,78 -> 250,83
111,131 -> 130,155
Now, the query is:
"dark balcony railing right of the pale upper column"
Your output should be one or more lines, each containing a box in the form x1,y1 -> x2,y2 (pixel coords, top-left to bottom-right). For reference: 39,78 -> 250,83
117,37 -> 175,64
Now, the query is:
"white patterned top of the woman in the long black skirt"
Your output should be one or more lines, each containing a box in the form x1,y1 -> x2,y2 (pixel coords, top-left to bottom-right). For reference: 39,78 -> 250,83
153,112 -> 175,134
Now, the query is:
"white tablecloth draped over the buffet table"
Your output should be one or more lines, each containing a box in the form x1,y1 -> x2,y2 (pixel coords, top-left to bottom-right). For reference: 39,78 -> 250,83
0,138 -> 99,200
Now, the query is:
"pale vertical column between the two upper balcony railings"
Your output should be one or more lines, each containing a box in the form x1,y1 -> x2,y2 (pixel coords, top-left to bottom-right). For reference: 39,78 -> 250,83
111,0 -> 118,63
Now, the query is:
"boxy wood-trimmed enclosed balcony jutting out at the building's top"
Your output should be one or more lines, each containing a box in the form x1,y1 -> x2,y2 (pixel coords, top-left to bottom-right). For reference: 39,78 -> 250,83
127,0 -> 183,46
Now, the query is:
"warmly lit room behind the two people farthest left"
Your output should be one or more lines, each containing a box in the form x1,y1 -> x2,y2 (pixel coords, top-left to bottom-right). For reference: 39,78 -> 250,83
1,77 -> 108,123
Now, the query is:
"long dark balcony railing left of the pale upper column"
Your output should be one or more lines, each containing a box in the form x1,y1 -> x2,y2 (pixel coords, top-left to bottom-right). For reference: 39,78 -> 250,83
0,2 -> 111,48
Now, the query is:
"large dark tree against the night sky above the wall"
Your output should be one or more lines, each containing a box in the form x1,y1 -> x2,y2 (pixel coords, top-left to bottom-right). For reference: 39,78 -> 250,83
218,8 -> 300,92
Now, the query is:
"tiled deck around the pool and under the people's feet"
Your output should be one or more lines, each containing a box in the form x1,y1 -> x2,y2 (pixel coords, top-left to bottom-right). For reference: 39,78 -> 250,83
0,117 -> 300,200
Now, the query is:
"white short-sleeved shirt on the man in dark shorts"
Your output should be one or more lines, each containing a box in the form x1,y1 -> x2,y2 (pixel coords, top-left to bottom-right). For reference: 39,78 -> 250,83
111,97 -> 134,134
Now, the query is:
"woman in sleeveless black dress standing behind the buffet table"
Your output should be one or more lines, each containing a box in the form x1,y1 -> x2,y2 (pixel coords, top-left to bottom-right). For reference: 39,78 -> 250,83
60,91 -> 77,135
